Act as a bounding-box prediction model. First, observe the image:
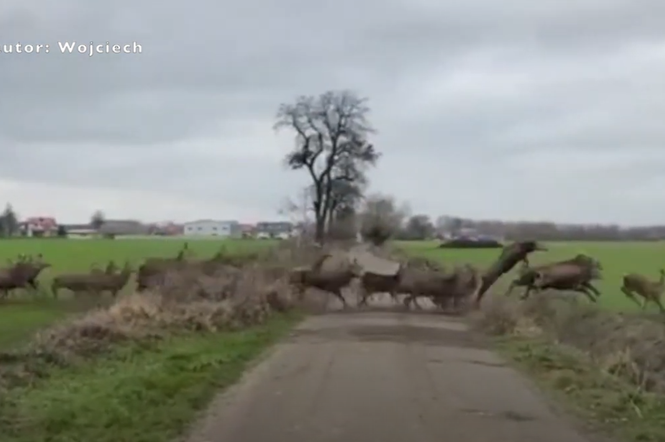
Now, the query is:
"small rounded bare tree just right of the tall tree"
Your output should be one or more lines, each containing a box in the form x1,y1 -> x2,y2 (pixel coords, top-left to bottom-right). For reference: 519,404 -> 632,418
360,194 -> 410,245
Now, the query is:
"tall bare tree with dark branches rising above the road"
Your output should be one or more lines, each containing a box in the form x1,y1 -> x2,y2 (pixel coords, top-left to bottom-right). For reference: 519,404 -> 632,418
275,91 -> 380,242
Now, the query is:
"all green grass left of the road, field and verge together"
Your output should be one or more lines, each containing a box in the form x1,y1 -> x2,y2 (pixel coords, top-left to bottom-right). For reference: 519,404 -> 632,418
0,239 -> 302,442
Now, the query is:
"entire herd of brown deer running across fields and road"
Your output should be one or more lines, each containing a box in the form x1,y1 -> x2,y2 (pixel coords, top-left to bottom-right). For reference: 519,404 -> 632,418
0,241 -> 665,313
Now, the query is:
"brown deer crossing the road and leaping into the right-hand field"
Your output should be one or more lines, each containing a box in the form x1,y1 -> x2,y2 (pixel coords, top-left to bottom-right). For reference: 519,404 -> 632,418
290,241 -> 665,313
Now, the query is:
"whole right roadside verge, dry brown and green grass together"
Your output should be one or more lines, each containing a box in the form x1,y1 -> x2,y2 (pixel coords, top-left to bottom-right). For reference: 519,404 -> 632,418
471,292 -> 665,441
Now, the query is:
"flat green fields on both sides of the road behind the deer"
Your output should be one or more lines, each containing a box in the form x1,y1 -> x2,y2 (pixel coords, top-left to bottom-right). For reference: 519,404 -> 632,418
0,239 -> 665,349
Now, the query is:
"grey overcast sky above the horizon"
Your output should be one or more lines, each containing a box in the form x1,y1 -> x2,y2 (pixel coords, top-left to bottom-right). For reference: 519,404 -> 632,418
0,0 -> 665,224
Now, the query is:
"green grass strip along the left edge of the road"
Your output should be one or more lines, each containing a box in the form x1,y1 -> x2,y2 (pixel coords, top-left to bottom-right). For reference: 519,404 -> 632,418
0,313 -> 302,442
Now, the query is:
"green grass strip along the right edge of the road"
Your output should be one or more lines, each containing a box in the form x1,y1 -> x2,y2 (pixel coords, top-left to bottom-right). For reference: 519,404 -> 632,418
496,336 -> 665,442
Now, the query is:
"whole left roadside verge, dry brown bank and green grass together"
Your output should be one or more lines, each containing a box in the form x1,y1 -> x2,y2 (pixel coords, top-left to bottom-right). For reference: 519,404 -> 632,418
0,242 -> 332,442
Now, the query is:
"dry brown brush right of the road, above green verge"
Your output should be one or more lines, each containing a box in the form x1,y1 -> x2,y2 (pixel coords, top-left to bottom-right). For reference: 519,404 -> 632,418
476,291 -> 665,394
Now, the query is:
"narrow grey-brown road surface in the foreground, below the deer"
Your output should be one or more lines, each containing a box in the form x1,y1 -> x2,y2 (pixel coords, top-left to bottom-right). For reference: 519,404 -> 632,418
184,312 -> 587,442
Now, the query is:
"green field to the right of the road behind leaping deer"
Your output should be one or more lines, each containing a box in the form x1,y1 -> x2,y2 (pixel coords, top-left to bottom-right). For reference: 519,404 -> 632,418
396,241 -> 665,311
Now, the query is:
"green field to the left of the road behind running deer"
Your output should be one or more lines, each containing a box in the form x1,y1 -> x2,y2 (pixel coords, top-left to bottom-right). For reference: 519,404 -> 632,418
0,238 -> 275,350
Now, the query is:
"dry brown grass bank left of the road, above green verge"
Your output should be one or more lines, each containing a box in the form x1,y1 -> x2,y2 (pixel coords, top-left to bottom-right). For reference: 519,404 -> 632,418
0,242 -> 320,391
